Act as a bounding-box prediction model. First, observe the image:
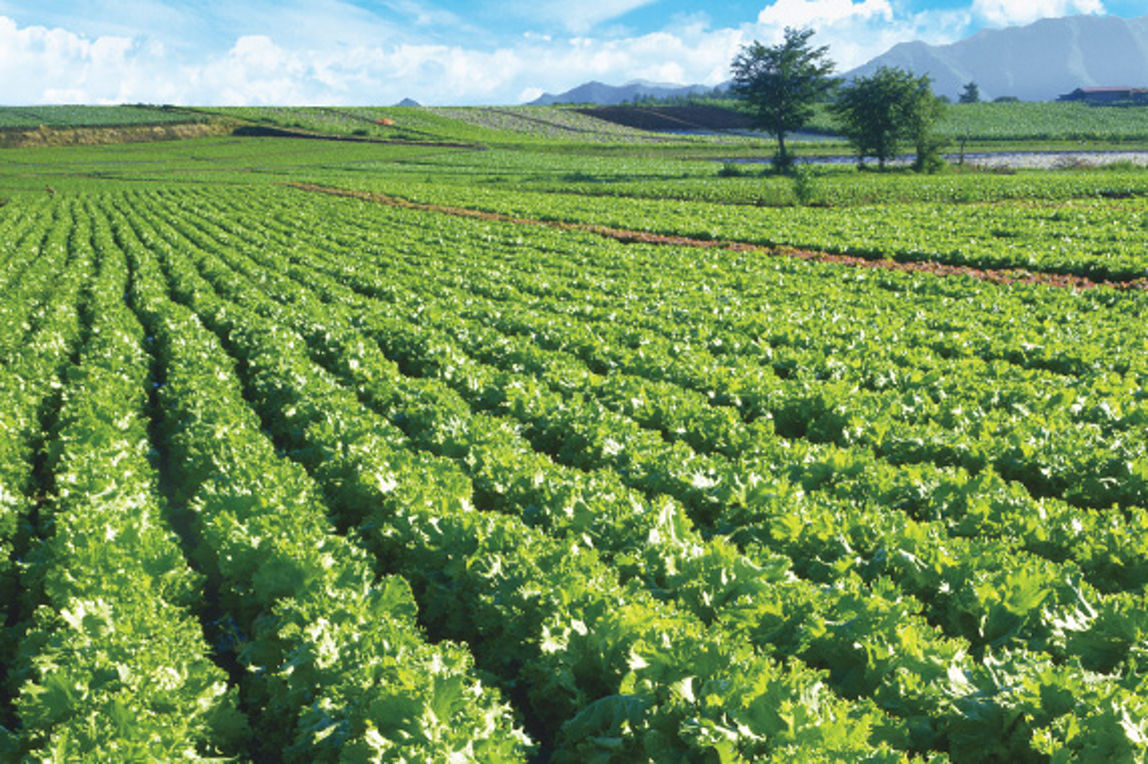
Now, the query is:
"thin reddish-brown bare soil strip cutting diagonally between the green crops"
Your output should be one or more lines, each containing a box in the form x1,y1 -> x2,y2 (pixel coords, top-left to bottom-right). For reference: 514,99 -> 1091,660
287,184 -> 1148,291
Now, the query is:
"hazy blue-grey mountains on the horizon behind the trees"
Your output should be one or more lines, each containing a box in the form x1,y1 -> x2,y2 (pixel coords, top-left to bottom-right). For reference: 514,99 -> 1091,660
532,16 -> 1148,106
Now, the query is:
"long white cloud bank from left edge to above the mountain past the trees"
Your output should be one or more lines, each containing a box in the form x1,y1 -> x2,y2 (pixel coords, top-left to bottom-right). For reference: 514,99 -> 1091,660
0,0 -> 987,106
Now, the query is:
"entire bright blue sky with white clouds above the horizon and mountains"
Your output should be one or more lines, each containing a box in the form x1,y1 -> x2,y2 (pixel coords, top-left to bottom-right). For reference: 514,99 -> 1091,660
0,0 -> 1148,104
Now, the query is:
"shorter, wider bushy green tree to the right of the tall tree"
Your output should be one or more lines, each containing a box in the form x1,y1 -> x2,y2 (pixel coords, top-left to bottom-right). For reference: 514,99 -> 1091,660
830,67 -> 943,170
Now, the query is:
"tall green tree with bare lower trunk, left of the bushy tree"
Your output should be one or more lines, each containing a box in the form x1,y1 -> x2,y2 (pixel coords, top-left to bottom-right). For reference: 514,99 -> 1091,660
730,28 -> 837,170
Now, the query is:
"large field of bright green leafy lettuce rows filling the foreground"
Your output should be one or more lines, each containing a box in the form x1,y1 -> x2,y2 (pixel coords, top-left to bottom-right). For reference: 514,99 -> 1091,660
0,122 -> 1148,764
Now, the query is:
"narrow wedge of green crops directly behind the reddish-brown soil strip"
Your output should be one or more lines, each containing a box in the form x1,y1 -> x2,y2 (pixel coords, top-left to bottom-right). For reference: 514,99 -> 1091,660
335,180 -> 1148,279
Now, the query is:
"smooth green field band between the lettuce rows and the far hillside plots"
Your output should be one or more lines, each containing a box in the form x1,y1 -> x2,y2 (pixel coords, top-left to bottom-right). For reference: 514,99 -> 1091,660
0,132 -> 1148,206
